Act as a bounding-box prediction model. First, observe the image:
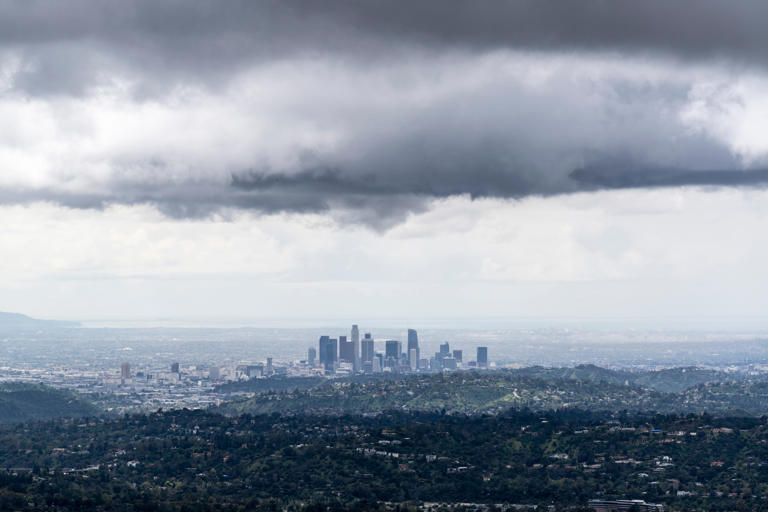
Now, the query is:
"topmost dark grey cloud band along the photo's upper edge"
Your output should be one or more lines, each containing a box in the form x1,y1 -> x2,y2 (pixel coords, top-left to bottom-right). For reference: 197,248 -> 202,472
0,0 -> 768,94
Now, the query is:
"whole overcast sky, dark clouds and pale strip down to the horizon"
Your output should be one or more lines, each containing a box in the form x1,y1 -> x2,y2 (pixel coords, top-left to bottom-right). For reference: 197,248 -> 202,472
0,0 -> 768,323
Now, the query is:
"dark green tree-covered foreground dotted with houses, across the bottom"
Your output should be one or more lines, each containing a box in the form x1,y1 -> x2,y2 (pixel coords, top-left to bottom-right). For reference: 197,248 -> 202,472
0,410 -> 768,510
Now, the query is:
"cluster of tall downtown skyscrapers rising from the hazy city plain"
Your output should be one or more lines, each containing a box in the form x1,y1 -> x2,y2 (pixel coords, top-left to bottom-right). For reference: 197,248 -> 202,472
307,325 -> 488,374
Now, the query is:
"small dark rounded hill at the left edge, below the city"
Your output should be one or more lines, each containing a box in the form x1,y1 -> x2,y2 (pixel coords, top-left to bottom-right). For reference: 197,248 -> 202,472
0,382 -> 100,423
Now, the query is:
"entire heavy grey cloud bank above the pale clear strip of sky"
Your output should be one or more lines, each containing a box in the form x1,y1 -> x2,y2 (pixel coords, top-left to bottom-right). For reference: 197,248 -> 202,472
0,0 -> 768,228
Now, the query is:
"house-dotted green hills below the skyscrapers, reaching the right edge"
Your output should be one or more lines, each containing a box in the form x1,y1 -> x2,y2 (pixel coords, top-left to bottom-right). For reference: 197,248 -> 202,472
217,367 -> 768,416
